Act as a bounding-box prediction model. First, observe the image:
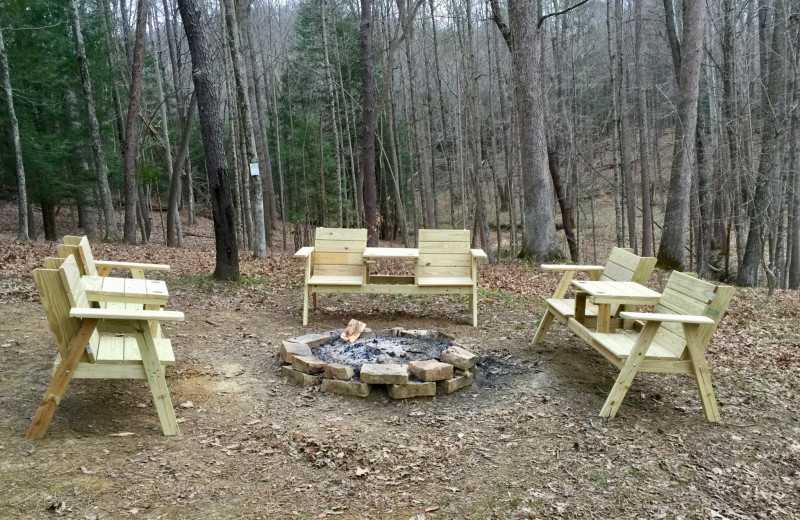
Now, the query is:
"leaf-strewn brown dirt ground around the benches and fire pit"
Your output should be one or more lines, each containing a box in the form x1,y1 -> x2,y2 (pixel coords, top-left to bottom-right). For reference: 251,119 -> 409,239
0,205 -> 800,520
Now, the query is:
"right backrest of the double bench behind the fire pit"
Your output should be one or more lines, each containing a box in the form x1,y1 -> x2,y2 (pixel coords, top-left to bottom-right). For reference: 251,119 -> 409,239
417,229 -> 472,278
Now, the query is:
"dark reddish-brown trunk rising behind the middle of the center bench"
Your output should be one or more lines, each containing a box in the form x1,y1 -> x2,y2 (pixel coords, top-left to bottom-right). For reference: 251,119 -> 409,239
356,0 -> 378,246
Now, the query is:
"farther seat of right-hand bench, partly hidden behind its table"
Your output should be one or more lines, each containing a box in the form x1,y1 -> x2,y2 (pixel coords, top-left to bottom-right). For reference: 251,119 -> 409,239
533,247 -> 656,344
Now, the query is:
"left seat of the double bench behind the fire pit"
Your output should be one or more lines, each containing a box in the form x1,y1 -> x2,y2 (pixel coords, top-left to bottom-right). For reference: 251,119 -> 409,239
294,228 -> 367,325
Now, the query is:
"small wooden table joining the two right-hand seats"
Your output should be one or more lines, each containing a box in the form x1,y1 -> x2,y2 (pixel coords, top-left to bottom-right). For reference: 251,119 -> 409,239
572,280 -> 661,333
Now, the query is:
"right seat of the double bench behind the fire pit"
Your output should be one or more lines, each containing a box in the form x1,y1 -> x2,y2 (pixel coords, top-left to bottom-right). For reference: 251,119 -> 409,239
416,229 -> 486,327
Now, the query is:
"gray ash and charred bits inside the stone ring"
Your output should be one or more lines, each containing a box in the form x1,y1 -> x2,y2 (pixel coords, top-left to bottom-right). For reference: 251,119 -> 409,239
314,336 -> 452,376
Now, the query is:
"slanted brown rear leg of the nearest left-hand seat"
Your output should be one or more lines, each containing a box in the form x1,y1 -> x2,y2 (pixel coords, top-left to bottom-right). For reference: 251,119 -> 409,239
26,319 -> 99,439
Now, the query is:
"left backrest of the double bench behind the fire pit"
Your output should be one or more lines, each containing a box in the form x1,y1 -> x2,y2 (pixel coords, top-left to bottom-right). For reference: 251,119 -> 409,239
311,228 -> 367,276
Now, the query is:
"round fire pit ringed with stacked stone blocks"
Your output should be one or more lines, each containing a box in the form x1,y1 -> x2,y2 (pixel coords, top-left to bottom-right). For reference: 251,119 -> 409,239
281,330 -> 478,399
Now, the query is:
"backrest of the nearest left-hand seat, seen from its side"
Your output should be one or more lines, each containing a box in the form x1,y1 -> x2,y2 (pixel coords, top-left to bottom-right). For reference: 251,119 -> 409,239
33,256 -> 99,362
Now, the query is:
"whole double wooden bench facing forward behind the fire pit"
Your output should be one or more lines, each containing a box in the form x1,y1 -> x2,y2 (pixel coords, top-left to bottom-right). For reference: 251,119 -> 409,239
295,228 -> 486,327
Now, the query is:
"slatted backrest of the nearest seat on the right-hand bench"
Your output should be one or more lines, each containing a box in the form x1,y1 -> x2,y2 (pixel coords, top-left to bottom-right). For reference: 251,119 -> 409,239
653,271 -> 735,359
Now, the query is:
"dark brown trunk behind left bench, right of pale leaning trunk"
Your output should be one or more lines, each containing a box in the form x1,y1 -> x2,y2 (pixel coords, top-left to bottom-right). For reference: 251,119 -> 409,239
122,0 -> 150,244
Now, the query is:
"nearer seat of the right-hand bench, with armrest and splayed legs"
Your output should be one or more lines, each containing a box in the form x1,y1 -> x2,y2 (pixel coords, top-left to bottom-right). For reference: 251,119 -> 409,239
567,271 -> 735,422
